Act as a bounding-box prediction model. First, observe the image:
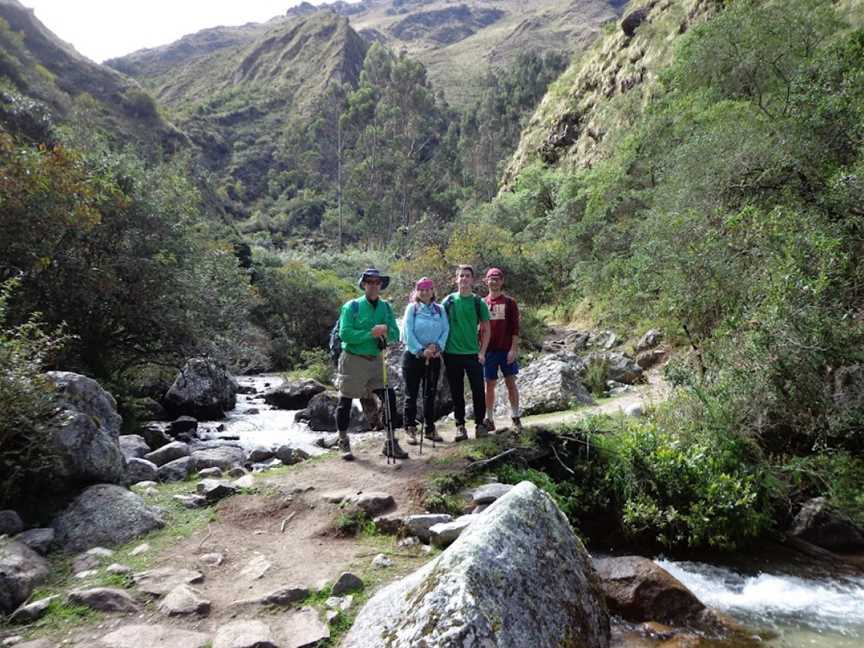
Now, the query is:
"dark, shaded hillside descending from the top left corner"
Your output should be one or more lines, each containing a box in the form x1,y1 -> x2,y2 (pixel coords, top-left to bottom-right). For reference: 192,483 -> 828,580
0,0 -> 184,150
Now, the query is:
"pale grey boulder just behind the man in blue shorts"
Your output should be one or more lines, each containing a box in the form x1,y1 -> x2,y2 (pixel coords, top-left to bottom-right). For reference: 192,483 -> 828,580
495,352 -> 594,416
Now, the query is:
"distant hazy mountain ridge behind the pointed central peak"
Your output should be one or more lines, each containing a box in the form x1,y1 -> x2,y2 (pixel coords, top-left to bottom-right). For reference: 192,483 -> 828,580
107,0 -> 624,105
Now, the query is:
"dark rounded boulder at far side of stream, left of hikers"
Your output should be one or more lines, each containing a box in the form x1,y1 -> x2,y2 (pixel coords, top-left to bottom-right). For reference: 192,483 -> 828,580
163,358 -> 237,420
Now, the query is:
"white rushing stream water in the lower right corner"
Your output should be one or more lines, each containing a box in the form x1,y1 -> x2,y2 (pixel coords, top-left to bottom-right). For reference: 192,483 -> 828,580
657,560 -> 864,648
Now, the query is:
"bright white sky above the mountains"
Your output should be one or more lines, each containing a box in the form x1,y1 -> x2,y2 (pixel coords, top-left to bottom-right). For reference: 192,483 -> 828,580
19,0 -> 322,62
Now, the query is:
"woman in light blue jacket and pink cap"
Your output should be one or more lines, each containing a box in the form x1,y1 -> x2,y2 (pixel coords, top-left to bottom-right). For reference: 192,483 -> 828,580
402,277 -> 450,445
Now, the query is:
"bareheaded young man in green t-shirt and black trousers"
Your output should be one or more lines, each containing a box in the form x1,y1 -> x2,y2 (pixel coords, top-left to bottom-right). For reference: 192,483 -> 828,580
442,265 -> 489,441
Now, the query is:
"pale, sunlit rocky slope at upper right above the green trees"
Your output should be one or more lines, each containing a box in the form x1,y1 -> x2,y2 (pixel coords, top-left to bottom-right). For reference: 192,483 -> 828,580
502,0 -> 718,189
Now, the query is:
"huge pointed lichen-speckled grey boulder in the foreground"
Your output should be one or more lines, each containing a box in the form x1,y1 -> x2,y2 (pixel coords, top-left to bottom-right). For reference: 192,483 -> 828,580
341,482 -> 609,648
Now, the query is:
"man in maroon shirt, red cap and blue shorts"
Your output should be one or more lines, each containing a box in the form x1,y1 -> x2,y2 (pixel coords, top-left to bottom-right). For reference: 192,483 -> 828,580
483,268 -> 522,434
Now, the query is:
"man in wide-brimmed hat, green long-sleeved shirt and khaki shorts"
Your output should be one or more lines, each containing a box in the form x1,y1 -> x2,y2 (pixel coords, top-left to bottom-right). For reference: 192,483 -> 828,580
336,268 -> 408,461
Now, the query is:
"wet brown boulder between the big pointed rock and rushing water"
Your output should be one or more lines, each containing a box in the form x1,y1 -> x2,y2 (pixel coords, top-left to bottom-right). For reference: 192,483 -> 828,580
594,556 -> 706,625
